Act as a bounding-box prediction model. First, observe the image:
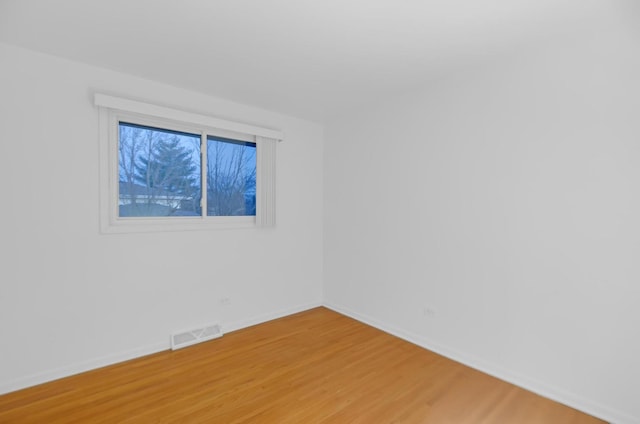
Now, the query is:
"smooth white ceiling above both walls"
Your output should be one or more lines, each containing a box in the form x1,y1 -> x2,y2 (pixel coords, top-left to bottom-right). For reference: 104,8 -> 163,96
0,0 -> 624,122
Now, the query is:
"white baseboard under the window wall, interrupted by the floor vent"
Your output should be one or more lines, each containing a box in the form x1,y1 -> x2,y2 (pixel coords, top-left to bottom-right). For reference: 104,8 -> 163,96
0,302 -> 322,395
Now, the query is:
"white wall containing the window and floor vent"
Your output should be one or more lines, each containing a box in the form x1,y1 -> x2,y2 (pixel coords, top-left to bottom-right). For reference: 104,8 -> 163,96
0,44 -> 323,393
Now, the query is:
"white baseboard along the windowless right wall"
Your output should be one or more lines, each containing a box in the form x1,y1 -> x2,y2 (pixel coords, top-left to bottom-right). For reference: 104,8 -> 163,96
324,302 -> 640,424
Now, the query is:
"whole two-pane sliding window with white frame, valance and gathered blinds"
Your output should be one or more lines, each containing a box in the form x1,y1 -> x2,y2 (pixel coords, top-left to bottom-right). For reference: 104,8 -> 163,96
95,94 -> 282,232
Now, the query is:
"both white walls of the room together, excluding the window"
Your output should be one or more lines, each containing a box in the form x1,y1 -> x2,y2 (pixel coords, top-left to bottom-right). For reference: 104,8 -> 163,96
0,4 -> 640,423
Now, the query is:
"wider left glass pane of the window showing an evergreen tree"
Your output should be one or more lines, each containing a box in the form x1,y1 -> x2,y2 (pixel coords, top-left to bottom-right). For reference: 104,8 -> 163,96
118,122 -> 202,217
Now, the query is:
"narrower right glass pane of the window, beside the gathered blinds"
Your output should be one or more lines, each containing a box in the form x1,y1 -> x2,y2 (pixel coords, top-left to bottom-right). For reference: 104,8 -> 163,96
207,136 -> 256,216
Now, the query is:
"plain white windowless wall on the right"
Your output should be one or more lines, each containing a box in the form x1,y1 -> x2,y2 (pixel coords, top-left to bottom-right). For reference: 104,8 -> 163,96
324,9 -> 640,423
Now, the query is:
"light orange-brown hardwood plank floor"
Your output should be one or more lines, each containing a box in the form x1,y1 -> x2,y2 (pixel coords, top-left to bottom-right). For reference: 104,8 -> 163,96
0,308 -> 603,424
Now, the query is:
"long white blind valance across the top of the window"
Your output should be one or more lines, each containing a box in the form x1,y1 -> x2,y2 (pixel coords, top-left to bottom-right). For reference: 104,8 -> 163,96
94,93 -> 284,141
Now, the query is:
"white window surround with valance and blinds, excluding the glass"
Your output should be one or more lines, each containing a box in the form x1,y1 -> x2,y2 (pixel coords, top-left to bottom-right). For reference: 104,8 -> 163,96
94,93 -> 284,234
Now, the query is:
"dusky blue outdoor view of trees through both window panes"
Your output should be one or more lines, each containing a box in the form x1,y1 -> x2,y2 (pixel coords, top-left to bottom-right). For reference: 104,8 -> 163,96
118,122 -> 256,217
